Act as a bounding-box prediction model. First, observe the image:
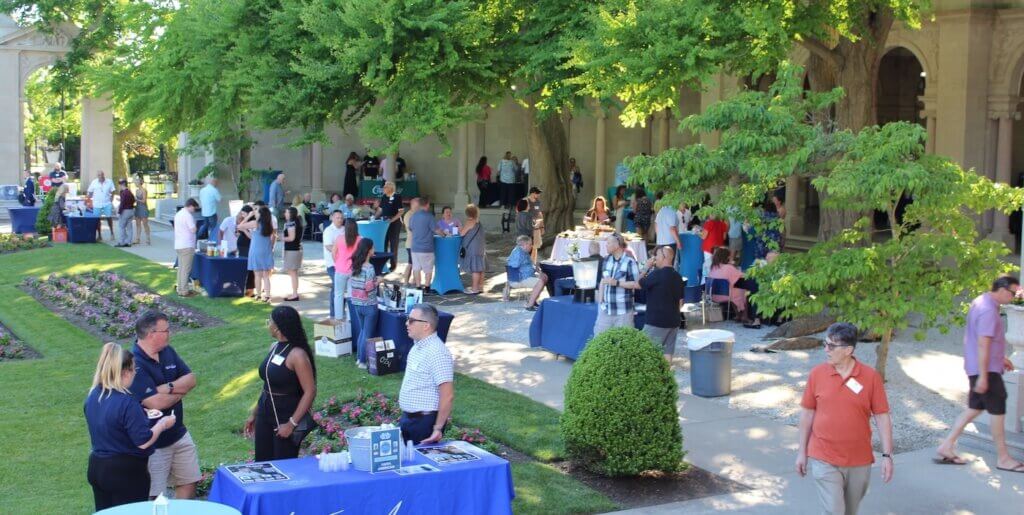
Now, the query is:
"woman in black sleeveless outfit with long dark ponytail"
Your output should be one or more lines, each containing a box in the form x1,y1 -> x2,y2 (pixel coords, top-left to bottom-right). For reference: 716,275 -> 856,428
243,306 -> 316,462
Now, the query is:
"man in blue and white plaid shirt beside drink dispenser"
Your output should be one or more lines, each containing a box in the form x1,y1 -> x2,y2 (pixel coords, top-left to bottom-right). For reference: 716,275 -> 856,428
594,232 -> 640,336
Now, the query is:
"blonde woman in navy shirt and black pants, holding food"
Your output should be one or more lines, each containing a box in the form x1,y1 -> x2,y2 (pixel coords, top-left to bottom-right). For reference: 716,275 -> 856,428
85,343 -> 175,511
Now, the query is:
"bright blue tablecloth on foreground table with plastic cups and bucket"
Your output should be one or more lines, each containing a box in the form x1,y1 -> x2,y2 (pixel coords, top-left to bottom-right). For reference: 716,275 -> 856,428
210,450 -> 515,515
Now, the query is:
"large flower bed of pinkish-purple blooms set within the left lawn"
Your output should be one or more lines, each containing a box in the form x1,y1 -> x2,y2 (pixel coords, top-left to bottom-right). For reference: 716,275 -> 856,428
22,271 -> 220,340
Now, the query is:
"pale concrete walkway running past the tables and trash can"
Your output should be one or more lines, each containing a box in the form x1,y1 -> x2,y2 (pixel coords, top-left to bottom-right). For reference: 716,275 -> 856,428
16,224 -> 1024,514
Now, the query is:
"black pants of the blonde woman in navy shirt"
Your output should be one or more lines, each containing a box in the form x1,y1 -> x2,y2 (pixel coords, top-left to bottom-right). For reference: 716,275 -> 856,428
86,455 -> 150,511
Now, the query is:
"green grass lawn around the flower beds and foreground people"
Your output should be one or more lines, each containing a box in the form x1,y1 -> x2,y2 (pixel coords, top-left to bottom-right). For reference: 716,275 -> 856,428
0,245 -> 615,514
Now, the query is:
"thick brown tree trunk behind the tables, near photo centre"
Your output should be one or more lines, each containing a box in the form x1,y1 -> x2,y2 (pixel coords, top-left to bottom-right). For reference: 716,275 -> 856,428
526,105 -> 574,245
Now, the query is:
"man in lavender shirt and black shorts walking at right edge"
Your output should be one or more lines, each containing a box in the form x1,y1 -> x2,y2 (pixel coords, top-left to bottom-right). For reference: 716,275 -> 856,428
935,275 -> 1024,472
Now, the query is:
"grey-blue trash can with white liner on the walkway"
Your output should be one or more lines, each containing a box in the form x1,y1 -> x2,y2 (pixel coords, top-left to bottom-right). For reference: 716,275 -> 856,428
686,329 -> 736,397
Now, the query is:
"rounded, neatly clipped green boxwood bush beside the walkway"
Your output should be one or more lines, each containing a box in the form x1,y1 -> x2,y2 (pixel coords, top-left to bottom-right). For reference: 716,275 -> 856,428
561,328 -> 683,476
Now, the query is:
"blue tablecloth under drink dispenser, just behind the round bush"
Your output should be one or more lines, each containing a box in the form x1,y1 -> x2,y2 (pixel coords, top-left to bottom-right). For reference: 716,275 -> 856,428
529,296 -> 644,359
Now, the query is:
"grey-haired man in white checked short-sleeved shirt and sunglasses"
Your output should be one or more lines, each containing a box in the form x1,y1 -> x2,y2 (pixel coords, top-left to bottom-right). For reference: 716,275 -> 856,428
398,303 -> 455,444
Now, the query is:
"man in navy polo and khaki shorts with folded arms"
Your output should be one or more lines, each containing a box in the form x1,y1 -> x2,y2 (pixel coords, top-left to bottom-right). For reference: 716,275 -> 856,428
131,310 -> 201,499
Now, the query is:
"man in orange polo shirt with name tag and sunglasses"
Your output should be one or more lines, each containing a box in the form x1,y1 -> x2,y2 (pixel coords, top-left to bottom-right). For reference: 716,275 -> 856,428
797,323 -> 893,515
